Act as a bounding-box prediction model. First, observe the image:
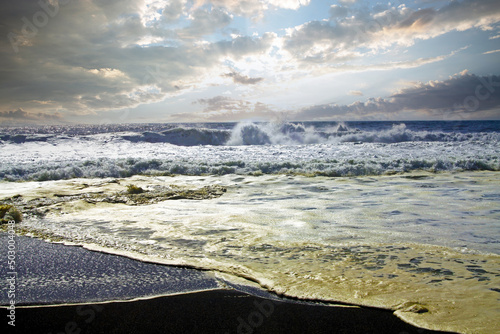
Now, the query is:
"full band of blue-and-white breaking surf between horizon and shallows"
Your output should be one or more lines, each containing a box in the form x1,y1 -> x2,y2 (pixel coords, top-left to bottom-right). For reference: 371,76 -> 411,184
0,122 -> 500,181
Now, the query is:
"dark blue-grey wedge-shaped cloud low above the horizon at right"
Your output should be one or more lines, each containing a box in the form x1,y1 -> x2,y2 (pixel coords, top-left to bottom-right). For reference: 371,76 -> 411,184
291,71 -> 500,120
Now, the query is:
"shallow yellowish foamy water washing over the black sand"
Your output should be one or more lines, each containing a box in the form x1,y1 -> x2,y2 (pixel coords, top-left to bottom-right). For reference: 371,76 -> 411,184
0,172 -> 500,333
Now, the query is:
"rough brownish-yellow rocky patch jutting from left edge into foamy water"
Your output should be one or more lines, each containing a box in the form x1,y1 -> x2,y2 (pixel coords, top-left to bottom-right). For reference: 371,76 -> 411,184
0,177 -> 226,222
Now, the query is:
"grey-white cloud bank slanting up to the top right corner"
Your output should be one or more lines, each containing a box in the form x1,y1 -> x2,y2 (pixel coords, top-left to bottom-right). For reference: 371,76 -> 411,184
283,0 -> 500,63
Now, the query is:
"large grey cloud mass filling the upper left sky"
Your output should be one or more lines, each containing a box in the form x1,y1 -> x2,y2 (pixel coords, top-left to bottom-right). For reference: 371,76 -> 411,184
0,0 -> 276,120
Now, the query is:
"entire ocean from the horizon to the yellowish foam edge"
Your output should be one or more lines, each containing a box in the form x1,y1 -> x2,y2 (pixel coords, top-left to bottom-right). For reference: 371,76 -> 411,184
0,121 -> 500,333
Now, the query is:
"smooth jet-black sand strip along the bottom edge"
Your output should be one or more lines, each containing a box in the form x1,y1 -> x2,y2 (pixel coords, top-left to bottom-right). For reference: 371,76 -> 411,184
17,290 -> 458,334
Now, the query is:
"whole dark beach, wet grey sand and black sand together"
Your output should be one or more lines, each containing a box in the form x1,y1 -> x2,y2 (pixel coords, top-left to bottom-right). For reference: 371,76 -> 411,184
0,235 -> 454,334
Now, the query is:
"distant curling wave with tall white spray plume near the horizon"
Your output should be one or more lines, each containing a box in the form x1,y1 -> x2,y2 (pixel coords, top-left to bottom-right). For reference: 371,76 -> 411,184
122,122 -> 500,146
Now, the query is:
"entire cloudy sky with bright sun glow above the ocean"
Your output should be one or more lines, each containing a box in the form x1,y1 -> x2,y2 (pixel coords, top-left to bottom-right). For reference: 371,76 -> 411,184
0,0 -> 500,125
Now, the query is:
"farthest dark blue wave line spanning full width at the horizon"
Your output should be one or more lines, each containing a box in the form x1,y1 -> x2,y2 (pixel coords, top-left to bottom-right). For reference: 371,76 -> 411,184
0,122 -> 500,146
